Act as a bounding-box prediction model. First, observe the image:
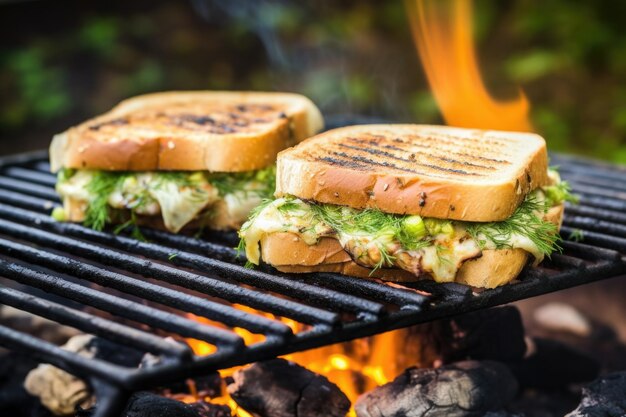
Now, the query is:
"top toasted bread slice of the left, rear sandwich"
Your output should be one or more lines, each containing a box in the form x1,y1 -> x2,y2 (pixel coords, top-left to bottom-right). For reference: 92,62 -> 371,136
50,91 -> 323,172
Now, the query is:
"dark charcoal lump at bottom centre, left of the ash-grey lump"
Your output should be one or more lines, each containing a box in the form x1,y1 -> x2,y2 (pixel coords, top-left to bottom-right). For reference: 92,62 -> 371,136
228,359 -> 350,417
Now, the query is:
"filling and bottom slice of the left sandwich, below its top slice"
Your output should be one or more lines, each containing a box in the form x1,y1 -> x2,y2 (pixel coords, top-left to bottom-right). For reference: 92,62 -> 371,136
53,166 -> 276,233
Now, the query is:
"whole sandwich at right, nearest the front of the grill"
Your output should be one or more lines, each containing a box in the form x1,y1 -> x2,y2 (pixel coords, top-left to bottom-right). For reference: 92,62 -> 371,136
240,125 -> 573,287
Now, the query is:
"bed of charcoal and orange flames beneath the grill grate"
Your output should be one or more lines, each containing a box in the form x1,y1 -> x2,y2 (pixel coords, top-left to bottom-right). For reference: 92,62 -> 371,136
0,303 -> 626,417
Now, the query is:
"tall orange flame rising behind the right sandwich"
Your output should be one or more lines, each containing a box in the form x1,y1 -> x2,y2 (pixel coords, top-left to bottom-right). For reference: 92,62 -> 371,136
405,0 -> 533,132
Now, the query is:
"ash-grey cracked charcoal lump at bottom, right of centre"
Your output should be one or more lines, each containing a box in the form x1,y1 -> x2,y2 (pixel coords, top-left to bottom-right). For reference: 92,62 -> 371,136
355,361 -> 518,417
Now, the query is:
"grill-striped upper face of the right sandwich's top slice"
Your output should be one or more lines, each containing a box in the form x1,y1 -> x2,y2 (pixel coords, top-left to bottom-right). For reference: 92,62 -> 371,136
304,132 -> 515,178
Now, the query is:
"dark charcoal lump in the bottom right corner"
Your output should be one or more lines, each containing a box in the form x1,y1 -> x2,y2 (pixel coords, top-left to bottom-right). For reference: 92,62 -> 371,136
565,372 -> 626,417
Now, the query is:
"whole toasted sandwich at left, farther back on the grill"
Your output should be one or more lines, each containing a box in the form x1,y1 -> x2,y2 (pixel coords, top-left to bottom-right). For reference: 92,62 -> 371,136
50,91 -> 323,232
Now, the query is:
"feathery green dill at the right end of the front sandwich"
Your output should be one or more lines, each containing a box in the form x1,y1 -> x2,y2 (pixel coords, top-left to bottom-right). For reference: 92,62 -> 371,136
467,195 -> 560,255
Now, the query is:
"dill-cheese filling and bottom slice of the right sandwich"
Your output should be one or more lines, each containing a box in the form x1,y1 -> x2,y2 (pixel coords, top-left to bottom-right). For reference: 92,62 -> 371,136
239,171 -> 575,288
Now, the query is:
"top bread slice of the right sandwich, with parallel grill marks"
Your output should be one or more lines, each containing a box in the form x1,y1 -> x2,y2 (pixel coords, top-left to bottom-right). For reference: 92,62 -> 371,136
276,125 -> 548,222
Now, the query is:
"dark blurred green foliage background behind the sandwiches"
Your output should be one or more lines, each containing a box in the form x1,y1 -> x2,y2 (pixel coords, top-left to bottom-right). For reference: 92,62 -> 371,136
0,0 -> 626,163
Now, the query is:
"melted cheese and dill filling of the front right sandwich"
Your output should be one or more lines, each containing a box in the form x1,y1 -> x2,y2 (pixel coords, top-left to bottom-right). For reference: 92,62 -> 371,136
240,172 -> 573,282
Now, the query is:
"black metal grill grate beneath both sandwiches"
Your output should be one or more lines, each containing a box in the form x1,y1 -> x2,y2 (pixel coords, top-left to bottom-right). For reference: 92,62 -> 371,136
0,153 -> 626,417
